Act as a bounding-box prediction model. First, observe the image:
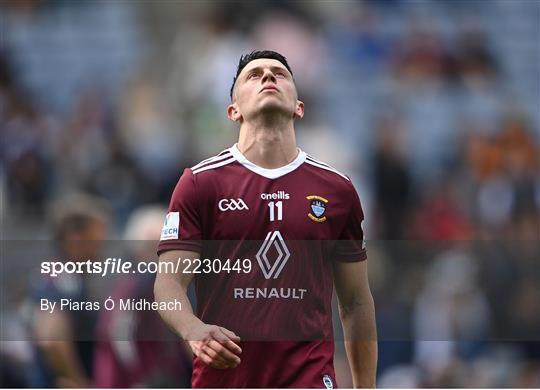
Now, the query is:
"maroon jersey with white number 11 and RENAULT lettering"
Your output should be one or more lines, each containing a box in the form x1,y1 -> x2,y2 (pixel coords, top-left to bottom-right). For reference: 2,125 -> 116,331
158,145 -> 366,388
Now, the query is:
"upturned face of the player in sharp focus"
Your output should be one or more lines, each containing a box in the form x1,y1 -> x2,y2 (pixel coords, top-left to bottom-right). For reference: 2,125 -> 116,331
227,58 -> 304,122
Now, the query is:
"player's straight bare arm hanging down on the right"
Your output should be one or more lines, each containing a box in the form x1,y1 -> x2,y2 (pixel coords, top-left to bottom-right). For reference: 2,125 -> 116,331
334,261 -> 377,388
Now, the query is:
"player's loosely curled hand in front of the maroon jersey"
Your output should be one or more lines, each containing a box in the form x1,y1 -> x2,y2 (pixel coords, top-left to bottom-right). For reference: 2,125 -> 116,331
188,324 -> 242,369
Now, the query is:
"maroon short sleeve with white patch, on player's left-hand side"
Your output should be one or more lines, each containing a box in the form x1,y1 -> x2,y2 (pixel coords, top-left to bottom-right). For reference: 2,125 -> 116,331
157,169 -> 202,255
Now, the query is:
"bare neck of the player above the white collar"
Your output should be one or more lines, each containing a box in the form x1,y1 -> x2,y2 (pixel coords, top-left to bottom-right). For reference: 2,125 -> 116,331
238,120 -> 298,169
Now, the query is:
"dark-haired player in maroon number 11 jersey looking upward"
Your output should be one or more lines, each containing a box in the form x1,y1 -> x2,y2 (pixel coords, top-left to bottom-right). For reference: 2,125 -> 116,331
154,51 -> 377,388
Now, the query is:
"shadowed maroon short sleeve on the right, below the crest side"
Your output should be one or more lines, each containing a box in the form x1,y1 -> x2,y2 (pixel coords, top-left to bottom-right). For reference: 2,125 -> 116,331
334,184 -> 367,262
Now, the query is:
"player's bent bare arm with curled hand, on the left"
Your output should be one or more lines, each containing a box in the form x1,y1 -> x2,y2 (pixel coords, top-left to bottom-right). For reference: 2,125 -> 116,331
154,251 -> 242,369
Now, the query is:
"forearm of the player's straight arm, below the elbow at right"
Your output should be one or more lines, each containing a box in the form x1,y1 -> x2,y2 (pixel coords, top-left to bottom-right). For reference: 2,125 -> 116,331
340,294 -> 377,388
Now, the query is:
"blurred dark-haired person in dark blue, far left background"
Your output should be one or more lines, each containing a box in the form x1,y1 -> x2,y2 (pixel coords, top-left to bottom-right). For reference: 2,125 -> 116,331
28,194 -> 109,387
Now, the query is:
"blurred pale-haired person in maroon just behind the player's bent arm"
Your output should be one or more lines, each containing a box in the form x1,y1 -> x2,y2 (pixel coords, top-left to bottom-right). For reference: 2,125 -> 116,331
94,206 -> 191,388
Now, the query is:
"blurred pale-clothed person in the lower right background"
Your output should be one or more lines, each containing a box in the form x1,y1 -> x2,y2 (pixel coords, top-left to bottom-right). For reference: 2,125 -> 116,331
414,250 -> 490,387
